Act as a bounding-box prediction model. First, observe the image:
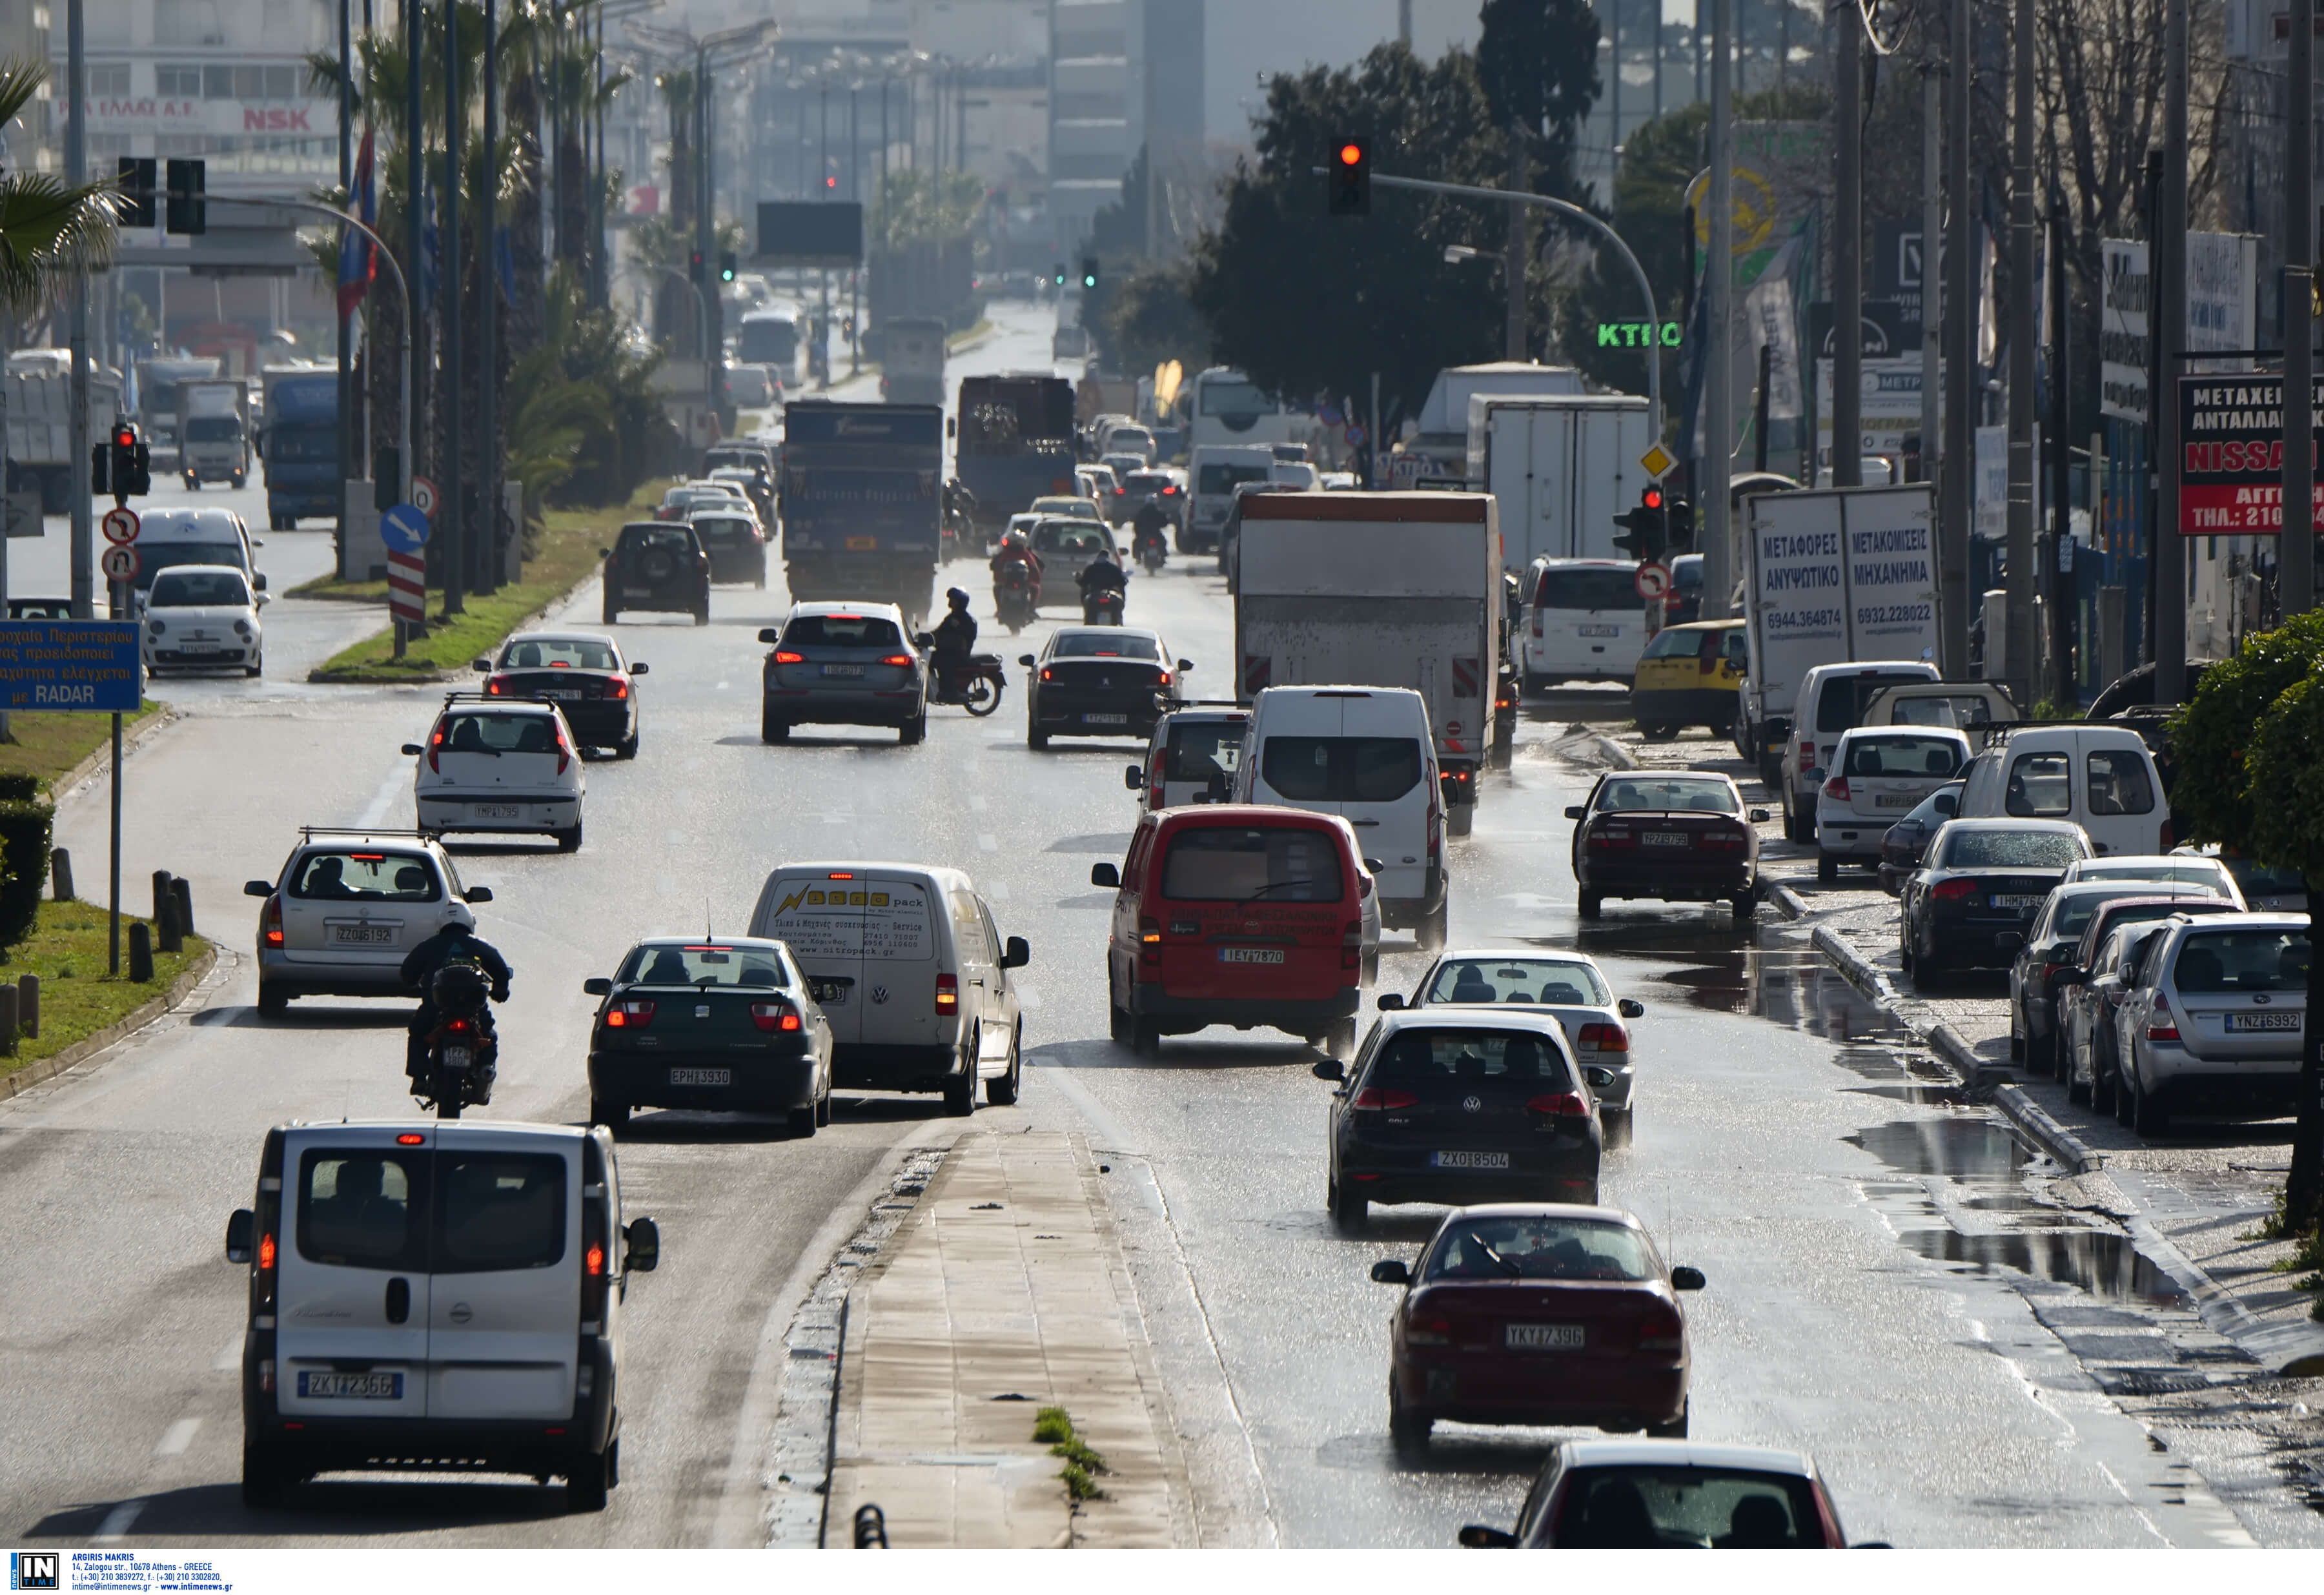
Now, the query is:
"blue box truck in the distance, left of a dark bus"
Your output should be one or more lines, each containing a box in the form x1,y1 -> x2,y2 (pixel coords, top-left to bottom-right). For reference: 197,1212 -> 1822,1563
776,400 -> 944,621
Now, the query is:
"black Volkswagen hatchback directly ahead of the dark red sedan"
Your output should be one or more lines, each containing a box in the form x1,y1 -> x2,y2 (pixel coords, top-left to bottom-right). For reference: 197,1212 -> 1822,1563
1316,1009 -> 1604,1228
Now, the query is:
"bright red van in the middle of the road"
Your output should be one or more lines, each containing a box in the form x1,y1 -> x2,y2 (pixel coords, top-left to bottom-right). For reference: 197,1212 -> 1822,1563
1090,802 -> 1380,1058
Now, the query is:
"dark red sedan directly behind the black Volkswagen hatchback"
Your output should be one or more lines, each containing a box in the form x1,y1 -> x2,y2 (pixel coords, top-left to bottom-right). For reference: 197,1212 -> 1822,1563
1371,1202 -> 1704,1453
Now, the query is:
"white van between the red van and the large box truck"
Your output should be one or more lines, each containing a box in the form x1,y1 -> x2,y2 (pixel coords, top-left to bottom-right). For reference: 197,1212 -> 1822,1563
1234,686 -> 1450,953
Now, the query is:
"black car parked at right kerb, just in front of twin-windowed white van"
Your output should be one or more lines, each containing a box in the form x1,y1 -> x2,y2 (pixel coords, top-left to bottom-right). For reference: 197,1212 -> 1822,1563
1899,818 -> 2092,984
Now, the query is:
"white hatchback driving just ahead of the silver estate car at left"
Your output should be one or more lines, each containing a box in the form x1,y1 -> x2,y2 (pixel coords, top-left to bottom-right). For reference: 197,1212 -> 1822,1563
404,693 -> 588,853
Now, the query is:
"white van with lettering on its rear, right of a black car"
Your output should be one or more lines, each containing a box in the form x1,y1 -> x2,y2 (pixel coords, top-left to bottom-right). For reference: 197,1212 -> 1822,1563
751,862 -> 1032,1113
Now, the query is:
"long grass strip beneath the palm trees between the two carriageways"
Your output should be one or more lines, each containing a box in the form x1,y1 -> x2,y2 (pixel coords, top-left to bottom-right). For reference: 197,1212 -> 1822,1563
290,482 -> 667,681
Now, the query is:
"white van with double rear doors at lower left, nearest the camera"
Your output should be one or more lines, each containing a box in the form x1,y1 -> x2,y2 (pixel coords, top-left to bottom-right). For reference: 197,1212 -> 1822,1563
225,1119 -> 662,1511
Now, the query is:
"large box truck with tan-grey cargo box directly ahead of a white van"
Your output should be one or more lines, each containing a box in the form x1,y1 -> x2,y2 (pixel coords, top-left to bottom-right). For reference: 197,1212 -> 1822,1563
1234,493 -> 1502,837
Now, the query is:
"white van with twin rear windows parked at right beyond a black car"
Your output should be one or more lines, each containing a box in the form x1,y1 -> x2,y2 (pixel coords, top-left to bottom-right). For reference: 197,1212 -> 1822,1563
1961,726 -> 2170,858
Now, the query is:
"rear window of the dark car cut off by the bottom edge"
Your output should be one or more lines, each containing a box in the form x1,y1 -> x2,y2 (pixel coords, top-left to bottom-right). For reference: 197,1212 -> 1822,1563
1550,1463 -> 1824,1551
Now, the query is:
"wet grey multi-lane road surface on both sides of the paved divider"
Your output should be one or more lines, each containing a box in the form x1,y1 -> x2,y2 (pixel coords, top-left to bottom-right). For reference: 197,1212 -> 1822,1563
0,307 -> 2324,1546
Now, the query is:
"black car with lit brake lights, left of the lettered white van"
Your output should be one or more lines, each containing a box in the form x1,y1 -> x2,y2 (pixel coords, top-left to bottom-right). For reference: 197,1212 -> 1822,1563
581,935 -> 832,1135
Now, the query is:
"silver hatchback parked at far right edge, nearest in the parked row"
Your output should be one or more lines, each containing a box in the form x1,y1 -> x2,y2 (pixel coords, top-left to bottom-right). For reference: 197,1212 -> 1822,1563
2115,914 -> 2310,1135
